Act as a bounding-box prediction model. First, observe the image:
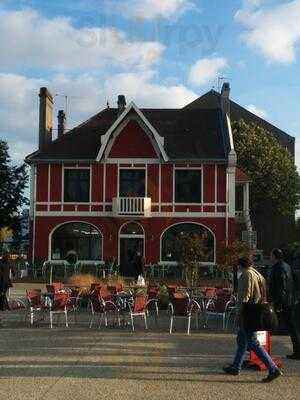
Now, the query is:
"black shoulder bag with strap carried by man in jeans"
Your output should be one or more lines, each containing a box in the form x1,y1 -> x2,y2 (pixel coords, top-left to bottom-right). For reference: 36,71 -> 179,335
242,271 -> 278,332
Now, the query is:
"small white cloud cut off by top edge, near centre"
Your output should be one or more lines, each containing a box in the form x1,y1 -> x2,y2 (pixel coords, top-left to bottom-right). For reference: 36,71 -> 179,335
110,0 -> 195,20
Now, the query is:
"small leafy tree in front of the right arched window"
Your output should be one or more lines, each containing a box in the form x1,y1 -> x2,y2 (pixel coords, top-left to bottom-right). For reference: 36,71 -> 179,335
176,234 -> 209,286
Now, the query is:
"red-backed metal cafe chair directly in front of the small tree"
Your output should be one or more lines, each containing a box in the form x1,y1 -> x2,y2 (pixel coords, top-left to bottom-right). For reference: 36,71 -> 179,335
169,293 -> 202,335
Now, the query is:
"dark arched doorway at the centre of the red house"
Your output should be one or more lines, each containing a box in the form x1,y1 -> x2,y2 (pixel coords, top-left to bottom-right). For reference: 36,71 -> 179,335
119,222 -> 145,276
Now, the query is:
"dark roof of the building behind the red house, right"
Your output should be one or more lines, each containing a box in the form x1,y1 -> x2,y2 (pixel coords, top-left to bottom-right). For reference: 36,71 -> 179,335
184,90 -> 295,155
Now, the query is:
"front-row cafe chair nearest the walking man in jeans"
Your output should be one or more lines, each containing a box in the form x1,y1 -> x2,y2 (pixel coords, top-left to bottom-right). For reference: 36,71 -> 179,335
205,294 -> 236,330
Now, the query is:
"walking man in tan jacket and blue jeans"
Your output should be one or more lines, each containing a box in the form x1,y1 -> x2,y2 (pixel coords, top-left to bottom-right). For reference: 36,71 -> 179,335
223,257 -> 282,383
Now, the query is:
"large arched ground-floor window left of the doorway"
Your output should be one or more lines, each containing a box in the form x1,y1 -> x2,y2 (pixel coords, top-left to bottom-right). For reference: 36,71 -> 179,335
51,222 -> 102,260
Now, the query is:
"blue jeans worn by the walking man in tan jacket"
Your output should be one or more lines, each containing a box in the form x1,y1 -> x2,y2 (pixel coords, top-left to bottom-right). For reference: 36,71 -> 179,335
232,329 -> 277,372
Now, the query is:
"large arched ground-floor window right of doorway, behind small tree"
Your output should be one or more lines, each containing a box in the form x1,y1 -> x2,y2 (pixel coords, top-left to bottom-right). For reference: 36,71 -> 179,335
161,223 -> 215,263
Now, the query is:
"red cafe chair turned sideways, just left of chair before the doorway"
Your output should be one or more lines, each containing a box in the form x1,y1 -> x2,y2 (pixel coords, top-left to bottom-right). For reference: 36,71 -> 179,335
89,288 -> 121,328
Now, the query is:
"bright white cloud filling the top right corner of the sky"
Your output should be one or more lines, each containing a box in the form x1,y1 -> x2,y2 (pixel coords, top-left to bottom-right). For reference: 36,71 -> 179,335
235,0 -> 300,64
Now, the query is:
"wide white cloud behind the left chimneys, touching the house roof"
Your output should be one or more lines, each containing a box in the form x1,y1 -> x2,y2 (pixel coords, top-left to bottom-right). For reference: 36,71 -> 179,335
0,71 -> 197,162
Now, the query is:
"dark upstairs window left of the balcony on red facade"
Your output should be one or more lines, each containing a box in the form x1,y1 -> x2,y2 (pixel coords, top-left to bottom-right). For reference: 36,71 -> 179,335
64,168 -> 90,203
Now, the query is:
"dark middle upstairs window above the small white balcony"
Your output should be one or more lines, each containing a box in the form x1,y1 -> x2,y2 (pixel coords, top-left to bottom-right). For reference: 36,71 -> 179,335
119,169 -> 145,197
